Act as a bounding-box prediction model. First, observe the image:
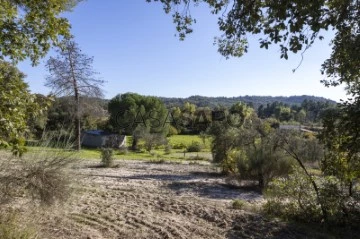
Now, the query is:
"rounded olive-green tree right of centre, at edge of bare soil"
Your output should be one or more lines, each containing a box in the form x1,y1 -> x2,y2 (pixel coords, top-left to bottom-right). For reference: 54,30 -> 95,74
210,104 -> 292,188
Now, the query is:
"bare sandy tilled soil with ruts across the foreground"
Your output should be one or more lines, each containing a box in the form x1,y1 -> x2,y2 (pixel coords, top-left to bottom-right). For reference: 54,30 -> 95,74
39,161 -> 316,239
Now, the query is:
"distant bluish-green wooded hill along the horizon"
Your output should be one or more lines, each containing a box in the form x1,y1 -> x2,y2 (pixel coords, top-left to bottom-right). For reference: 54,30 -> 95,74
158,95 -> 336,108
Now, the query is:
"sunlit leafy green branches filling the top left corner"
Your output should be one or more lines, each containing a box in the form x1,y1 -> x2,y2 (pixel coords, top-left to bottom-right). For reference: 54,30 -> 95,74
0,0 -> 81,64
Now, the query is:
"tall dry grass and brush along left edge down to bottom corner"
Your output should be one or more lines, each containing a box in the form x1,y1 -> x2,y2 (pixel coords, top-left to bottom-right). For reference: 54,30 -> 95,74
0,135 -> 76,239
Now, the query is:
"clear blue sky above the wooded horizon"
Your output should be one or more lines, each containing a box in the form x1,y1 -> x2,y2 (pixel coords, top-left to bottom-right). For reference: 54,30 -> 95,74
19,0 -> 346,101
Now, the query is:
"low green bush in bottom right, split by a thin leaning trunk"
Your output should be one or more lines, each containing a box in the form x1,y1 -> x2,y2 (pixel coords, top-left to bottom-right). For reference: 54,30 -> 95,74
264,169 -> 360,226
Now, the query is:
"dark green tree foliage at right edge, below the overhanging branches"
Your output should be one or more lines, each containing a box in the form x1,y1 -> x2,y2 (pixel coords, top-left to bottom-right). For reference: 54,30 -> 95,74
320,107 -> 360,197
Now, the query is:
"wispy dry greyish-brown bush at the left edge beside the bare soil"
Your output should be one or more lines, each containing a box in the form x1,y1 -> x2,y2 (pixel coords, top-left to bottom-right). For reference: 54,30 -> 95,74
0,151 -> 74,206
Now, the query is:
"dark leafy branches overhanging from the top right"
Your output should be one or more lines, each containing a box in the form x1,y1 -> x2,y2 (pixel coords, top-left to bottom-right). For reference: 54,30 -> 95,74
147,0 -> 360,88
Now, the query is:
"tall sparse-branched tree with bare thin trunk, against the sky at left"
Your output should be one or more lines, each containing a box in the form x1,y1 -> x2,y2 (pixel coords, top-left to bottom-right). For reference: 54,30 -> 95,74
45,40 -> 104,150
